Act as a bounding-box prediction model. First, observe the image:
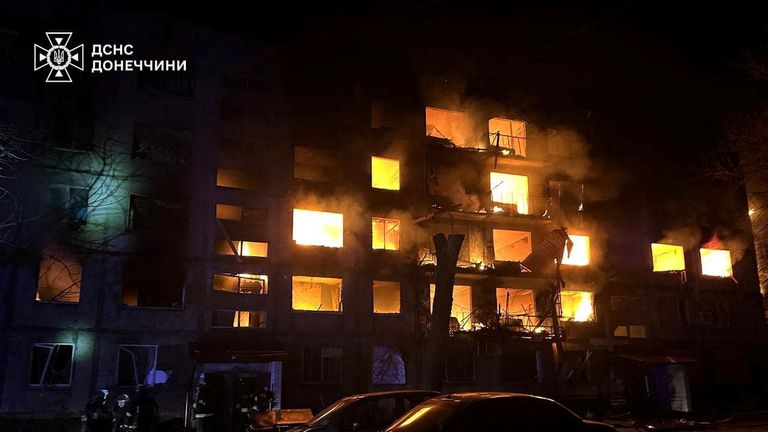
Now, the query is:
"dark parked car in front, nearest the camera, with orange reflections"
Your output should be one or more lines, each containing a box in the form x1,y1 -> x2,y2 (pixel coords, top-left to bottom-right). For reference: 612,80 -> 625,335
386,393 -> 616,432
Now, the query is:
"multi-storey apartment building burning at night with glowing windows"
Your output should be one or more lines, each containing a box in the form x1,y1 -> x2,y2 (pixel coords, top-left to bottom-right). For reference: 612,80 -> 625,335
0,2 -> 764,428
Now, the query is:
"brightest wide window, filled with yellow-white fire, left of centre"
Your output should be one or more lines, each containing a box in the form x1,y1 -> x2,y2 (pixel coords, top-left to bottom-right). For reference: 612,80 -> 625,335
293,209 -> 344,248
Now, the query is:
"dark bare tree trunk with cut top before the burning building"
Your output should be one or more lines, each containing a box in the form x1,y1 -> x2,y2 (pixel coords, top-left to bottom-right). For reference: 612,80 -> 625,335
422,233 -> 464,391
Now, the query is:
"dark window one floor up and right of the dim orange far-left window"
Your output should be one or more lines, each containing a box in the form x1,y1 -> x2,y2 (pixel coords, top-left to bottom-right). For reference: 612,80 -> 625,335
128,195 -> 187,234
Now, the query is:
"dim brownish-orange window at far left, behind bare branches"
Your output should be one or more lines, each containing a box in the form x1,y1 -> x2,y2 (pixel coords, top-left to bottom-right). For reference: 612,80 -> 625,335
35,245 -> 83,303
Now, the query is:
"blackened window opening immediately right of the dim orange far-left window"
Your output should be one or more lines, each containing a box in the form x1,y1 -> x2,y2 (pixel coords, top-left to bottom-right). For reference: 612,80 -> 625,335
122,253 -> 186,307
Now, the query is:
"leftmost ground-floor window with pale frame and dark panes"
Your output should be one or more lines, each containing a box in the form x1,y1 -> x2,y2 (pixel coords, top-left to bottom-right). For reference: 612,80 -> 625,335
29,343 -> 75,387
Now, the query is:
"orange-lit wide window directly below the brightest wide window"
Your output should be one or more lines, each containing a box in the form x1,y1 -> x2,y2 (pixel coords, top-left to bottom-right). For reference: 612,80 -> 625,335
291,276 -> 341,312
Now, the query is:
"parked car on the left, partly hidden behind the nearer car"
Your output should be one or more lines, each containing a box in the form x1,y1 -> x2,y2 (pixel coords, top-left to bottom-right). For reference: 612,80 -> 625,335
289,390 -> 440,432
